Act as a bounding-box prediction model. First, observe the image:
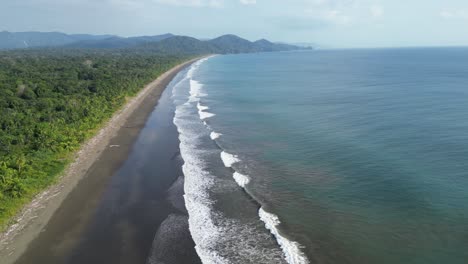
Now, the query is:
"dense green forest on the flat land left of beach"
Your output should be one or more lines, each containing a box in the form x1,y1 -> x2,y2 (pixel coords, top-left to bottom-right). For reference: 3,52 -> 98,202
0,49 -> 195,229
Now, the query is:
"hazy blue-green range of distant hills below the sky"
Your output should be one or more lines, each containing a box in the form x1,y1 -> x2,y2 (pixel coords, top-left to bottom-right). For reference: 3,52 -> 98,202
0,31 -> 303,54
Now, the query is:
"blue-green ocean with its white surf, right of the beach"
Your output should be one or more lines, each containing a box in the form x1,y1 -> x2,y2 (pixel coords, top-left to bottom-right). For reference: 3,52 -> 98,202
171,48 -> 468,264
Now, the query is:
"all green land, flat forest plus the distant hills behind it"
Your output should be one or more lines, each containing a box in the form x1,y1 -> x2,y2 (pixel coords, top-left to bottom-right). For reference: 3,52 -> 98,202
0,32 -> 299,230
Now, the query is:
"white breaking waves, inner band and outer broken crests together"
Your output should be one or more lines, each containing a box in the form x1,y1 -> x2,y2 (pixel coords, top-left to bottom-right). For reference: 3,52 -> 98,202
173,56 -> 309,264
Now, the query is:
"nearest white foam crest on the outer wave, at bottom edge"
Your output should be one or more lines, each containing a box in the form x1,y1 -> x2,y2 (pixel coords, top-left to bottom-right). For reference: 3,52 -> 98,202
258,208 -> 309,264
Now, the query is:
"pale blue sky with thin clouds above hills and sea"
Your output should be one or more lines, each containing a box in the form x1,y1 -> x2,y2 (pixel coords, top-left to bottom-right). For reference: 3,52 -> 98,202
0,0 -> 468,48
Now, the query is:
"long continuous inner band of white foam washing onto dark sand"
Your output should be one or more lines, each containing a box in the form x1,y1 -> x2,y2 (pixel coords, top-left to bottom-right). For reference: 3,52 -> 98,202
173,56 -> 228,264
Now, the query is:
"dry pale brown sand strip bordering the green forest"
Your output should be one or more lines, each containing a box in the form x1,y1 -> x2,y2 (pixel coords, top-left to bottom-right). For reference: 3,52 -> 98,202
0,57 -> 203,264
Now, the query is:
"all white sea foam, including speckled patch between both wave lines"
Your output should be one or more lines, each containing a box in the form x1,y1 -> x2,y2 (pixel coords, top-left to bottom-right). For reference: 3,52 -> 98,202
173,55 -> 308,264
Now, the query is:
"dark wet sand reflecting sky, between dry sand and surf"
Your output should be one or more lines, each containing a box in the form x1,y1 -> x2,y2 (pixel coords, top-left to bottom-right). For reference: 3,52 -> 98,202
16,65 -> 200,264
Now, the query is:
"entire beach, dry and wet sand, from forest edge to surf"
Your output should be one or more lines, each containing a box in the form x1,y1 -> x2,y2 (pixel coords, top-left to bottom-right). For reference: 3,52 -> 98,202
0,57 -> 205,264
